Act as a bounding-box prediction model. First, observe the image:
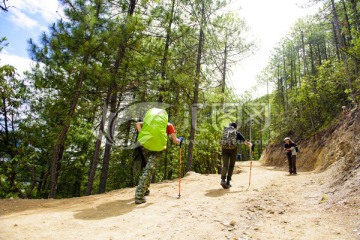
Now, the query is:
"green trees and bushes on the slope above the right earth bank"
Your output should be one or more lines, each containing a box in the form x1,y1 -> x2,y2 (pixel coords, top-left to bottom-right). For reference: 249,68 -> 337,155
256,0 -> 360,142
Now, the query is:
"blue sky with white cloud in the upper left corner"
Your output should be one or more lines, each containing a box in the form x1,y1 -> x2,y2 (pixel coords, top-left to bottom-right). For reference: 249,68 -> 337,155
0,0 -> 62,73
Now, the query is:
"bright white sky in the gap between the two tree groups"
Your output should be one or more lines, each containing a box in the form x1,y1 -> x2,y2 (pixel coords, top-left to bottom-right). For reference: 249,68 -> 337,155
230,0 -> 318,96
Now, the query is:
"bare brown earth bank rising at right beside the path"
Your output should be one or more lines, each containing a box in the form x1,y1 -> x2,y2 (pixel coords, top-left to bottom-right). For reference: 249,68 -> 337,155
260,109 -> 360,211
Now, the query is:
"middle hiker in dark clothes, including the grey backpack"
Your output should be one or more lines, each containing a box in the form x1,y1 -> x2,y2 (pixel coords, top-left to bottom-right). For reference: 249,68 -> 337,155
220,122 -> 252,189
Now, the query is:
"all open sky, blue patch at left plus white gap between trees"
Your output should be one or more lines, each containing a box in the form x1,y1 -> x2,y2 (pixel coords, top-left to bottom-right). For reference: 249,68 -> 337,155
0,0 -> 320,95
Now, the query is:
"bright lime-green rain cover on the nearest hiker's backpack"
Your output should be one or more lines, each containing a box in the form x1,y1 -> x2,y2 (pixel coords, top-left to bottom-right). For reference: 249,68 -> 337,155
138,108 -> 168,152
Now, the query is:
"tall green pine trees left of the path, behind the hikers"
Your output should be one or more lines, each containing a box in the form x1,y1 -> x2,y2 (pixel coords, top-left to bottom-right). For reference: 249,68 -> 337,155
0,0 -> 254,198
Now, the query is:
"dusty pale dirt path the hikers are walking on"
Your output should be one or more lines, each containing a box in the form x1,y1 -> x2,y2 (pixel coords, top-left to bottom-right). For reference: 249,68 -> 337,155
0,162 -> 360,240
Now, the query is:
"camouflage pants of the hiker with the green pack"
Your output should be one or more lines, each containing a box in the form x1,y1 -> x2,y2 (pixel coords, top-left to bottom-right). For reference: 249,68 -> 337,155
135,148 -> 162,199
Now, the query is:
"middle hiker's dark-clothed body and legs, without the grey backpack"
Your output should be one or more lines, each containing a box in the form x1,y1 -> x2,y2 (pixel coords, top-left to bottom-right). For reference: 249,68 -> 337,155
220,122 -> 251,189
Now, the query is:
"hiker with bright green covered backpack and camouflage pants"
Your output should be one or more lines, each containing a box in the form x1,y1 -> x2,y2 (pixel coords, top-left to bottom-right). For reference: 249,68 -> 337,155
135,108 -> 184,204
